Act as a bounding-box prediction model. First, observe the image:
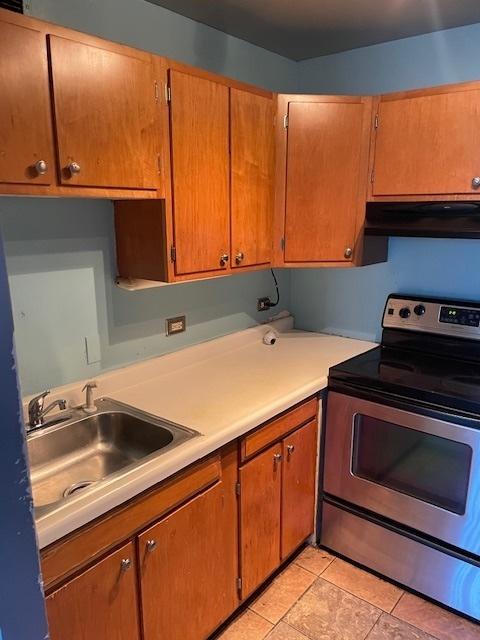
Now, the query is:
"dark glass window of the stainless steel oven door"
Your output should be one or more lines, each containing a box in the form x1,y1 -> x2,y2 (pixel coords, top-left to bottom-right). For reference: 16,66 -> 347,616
352,414 -> 472,514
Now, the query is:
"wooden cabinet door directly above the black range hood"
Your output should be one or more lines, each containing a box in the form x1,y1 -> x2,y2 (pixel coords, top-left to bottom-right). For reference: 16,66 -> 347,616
373,83 -> 480,196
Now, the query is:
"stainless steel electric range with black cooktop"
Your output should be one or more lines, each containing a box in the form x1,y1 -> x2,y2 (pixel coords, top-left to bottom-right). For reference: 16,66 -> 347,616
320,295 -> 480,620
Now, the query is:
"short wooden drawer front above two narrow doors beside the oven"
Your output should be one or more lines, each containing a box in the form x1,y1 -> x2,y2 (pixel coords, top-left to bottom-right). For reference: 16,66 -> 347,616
240,398 -> 318,461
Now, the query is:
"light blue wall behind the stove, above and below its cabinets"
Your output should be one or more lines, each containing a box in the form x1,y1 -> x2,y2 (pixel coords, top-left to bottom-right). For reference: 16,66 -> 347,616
291,24 -> 480,340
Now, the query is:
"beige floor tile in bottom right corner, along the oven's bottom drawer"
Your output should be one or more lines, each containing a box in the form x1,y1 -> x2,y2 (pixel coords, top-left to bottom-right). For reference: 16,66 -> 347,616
393,593 -> 480,640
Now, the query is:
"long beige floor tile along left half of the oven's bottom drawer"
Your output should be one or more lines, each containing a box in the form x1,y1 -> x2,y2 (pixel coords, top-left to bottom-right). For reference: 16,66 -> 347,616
322,558 -> 403,613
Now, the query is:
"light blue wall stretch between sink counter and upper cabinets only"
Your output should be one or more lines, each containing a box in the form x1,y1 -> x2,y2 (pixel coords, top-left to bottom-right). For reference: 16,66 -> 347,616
0,198 -> 289,395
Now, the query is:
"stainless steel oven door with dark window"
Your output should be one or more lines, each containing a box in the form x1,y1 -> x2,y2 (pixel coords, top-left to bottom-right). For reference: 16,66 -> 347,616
324,392 -> 480,555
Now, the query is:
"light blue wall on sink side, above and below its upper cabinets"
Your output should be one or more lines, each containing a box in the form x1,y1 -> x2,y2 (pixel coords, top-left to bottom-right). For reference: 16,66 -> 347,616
0,0 -> 296,394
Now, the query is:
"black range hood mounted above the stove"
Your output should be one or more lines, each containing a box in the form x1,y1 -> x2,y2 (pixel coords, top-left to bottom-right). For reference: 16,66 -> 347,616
365,200 -> 480,238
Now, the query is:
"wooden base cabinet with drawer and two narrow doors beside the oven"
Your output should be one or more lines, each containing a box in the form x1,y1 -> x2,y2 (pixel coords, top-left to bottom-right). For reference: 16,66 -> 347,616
239,399 -> 318,598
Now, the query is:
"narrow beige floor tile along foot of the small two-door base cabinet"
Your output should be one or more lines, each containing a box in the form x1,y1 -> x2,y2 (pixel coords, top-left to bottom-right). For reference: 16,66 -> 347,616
250,564 -> 315,624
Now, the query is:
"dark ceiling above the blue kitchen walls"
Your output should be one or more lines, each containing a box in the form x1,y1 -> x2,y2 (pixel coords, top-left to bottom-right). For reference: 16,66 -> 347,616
148,0 -> 480,60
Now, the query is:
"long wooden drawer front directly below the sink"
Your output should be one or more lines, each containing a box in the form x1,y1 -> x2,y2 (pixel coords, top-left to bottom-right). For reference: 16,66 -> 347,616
42,455 -> 222,590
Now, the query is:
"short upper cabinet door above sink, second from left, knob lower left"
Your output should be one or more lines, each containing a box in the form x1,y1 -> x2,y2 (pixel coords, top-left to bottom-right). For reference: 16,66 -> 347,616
49,36 -> 159,189
